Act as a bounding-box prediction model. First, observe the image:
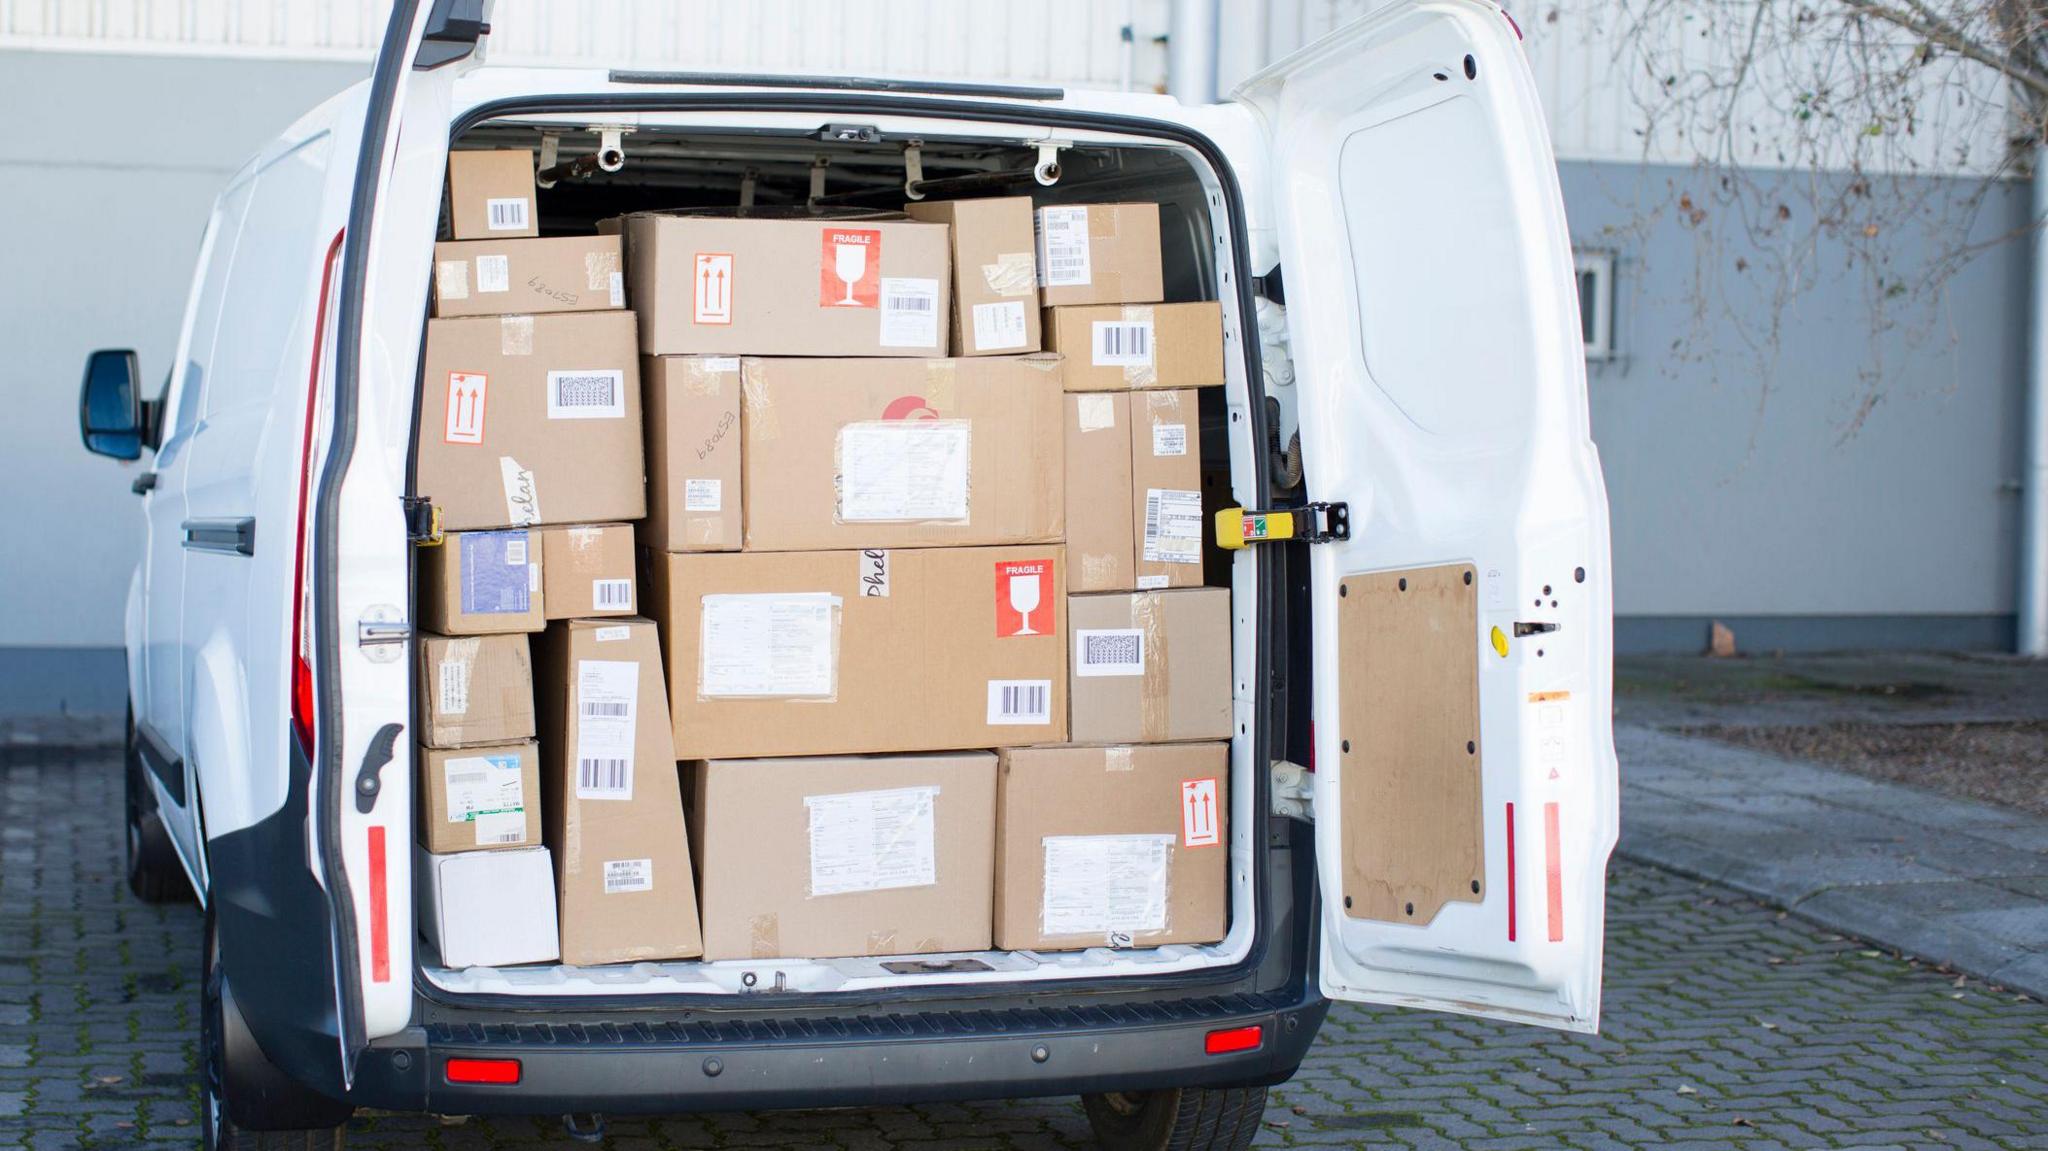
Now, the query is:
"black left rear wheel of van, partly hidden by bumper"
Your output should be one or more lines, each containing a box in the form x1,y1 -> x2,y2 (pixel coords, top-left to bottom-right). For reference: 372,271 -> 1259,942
199,909 -> 352,1151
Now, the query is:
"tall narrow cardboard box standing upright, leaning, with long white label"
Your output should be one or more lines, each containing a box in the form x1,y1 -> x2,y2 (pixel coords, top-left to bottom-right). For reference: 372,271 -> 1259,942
537,619 -> 702,967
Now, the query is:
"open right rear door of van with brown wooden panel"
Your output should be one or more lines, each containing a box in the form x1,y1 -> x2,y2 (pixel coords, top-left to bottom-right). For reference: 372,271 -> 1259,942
1235,0 -> 1618,1030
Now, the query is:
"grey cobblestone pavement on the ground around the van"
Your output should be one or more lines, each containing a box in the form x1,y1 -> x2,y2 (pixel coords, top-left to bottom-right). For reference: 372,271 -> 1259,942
0,754 -> 2048,1151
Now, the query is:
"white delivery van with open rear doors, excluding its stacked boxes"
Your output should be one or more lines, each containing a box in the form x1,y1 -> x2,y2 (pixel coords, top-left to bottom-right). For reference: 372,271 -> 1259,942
80,0 -> 1618,1147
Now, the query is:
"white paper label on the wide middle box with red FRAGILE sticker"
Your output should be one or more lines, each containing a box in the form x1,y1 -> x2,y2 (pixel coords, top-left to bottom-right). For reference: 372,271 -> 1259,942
696,592 -> 840,698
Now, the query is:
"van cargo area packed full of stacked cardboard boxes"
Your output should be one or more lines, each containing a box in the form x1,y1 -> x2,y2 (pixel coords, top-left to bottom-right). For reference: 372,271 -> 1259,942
414,111 -> 1292,1001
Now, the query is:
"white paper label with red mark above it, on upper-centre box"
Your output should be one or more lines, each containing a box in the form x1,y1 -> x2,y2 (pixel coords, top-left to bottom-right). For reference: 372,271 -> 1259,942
840,420 -> 971,522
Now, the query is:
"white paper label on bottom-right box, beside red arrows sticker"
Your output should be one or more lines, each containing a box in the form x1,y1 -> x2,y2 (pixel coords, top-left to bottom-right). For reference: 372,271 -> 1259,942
1040,836 -> 1174,946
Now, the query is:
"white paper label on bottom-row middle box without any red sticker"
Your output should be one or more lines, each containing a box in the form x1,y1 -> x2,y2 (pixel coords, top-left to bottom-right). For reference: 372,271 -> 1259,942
803,786 -> 938,895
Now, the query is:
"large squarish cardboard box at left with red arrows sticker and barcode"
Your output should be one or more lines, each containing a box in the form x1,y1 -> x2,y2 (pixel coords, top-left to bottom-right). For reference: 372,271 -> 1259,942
418,311 -> 647,530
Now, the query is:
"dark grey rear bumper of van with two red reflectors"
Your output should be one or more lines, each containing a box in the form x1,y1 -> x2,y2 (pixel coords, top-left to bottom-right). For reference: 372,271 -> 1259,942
348,991 -> 1329,1114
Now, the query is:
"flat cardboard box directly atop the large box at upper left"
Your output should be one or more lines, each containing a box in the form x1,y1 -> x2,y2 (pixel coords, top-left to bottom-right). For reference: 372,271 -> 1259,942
434,236 -> 627,317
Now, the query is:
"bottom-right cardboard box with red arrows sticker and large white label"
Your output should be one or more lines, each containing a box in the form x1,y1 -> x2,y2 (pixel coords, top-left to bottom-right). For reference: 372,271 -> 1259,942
995,743 -> 1231,950
